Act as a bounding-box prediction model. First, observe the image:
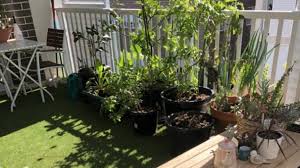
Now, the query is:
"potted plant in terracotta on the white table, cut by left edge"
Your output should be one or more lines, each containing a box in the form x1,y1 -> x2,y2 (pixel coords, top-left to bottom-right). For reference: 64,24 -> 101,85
0,5 -> 13,43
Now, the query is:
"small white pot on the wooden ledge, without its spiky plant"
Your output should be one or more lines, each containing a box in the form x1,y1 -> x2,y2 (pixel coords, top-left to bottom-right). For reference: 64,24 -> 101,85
256,131 -> 283,159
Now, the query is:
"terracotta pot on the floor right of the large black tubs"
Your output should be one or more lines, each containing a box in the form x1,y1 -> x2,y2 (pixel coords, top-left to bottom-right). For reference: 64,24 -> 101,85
210,96 -> 239,132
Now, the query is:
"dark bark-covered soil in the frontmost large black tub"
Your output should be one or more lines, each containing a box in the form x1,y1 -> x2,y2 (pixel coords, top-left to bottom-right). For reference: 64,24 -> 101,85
171,113 -> 210,128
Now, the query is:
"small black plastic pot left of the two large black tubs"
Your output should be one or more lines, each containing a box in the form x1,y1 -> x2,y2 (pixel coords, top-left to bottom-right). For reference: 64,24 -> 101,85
131,110 -> 158,135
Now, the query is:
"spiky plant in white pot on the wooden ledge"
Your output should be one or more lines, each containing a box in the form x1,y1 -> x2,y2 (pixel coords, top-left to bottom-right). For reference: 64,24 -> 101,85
252,66 -> 300,159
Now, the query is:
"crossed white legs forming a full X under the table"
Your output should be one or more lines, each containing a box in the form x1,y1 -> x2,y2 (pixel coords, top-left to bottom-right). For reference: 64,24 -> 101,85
3,48 -> 54,111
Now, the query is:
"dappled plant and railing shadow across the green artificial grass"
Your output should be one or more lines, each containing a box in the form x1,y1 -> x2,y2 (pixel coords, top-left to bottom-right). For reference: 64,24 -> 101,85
0,87 -> 171,168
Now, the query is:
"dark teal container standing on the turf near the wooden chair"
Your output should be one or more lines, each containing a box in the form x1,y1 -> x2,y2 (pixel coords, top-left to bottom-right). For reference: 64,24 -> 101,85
67,73 -> 82,100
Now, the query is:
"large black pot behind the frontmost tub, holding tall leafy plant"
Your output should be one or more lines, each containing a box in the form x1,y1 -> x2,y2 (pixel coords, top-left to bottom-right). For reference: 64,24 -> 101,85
161,86 -> 214,115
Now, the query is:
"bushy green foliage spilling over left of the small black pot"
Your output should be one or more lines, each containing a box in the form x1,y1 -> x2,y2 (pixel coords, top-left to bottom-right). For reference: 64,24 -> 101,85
101,49 -> 142,122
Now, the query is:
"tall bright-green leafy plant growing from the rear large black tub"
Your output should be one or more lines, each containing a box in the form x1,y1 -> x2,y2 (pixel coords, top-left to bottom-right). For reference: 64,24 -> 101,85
164,0 -> 242,97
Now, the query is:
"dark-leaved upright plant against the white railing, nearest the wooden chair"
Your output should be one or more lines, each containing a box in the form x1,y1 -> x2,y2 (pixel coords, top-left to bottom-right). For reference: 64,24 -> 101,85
73,11 -> 122,68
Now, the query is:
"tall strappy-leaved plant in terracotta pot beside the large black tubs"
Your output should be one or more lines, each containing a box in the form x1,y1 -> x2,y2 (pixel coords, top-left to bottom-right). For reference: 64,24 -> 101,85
210,31 -> 277,132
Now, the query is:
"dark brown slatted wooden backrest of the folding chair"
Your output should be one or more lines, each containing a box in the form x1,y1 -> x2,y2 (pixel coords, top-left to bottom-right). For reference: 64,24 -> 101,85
47,28 -> 65,48
